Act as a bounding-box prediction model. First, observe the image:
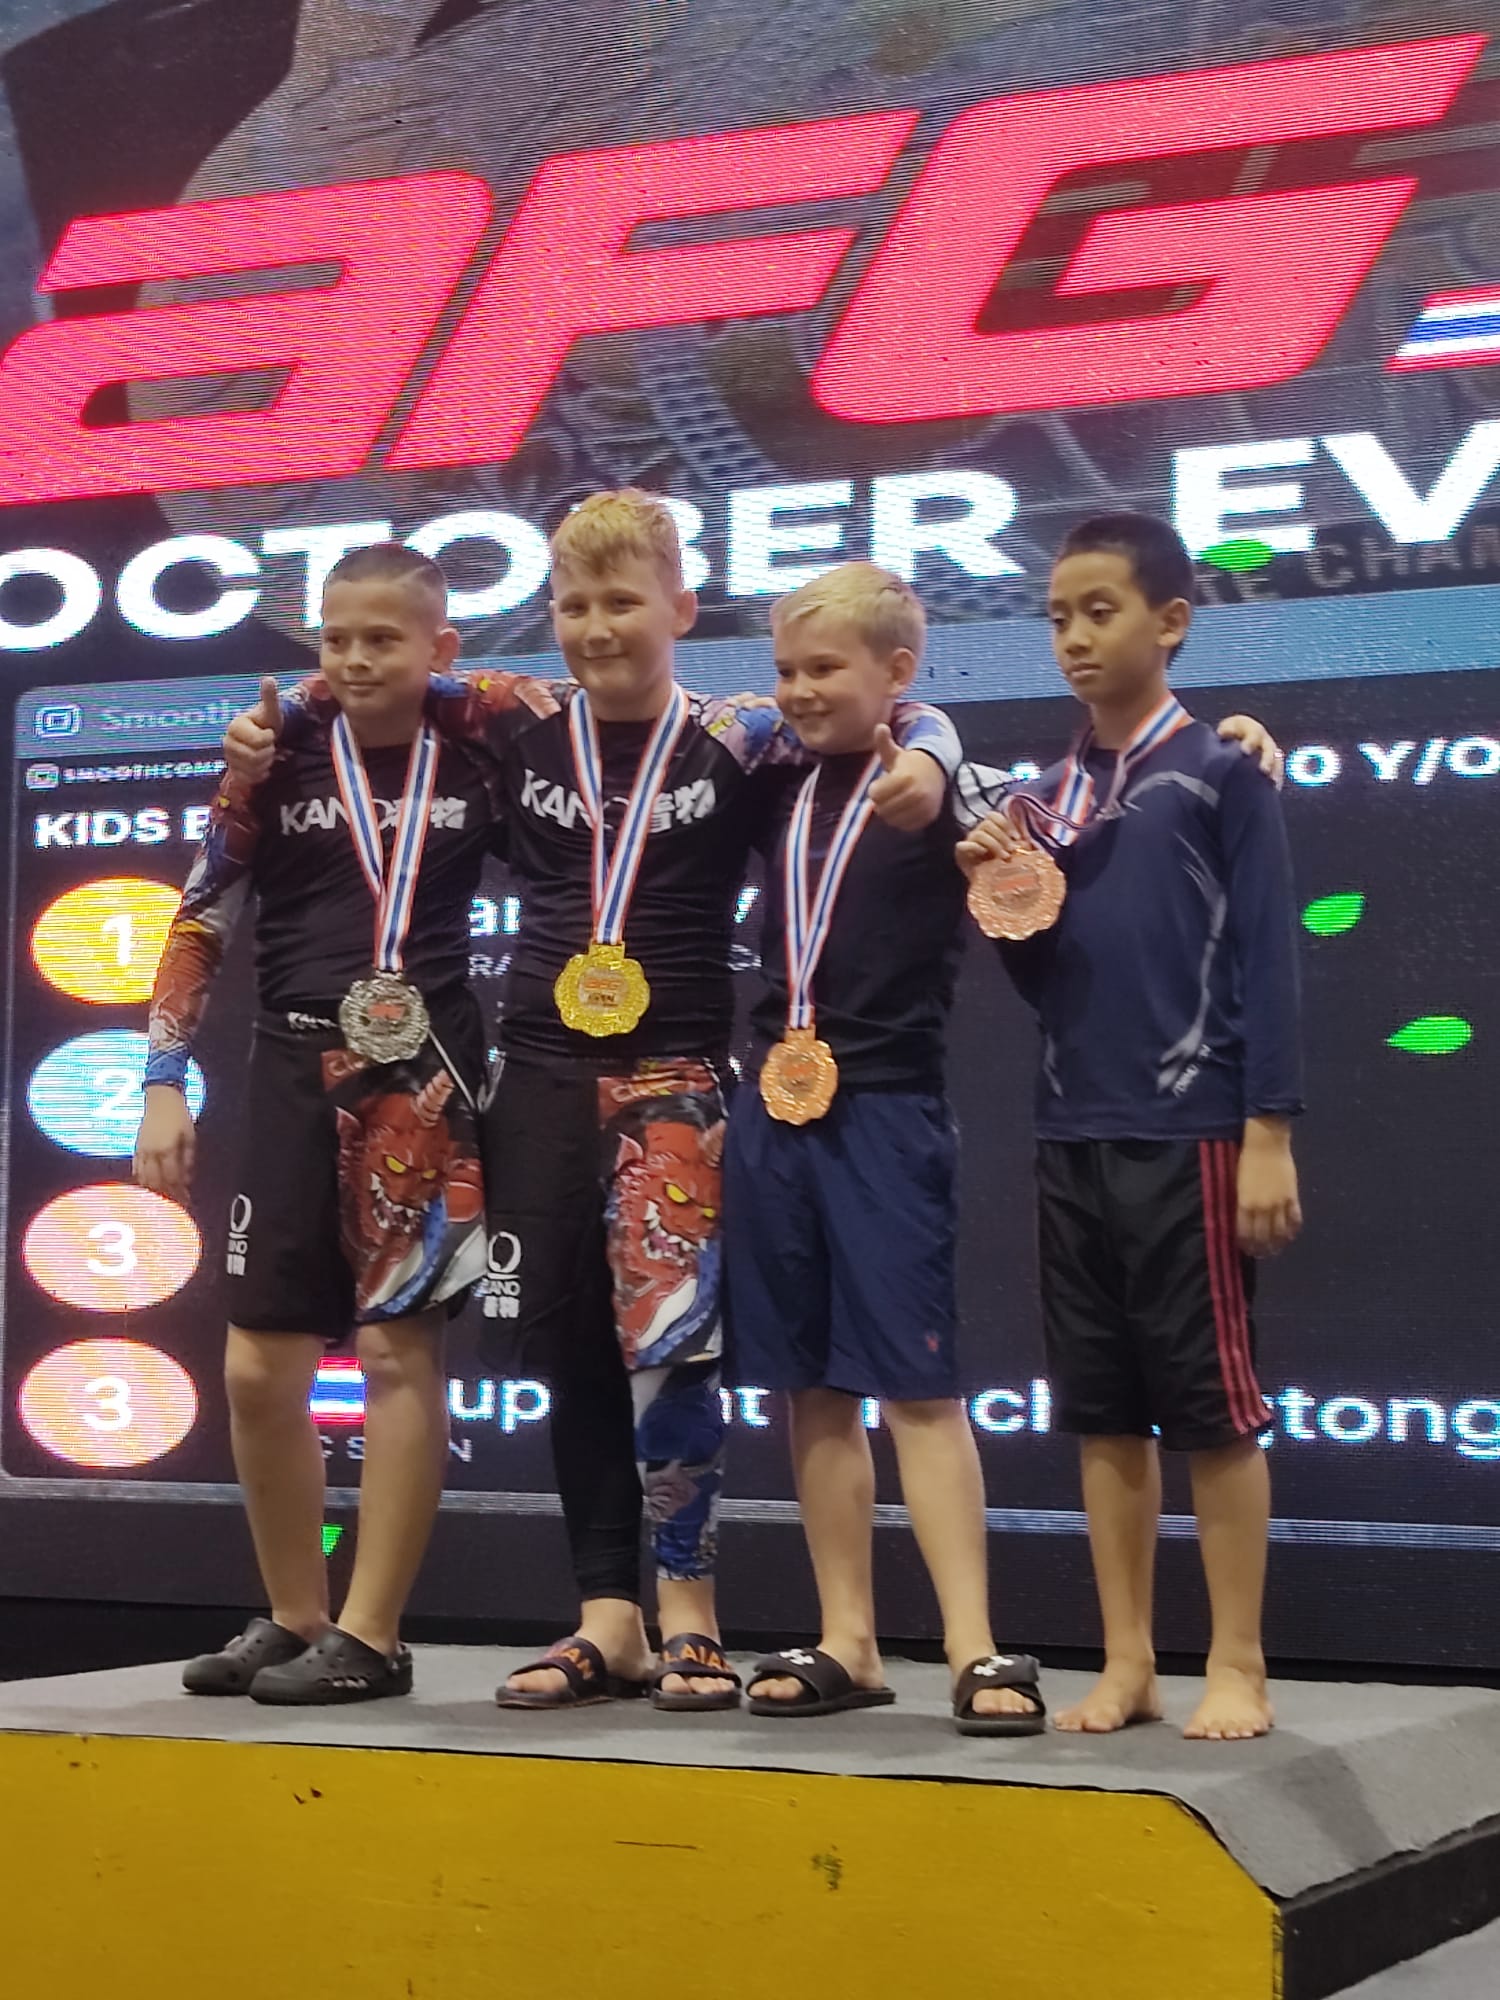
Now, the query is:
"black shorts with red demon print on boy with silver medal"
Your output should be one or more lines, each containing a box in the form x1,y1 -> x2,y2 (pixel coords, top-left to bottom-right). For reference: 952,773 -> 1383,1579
226,994 -> 486,1346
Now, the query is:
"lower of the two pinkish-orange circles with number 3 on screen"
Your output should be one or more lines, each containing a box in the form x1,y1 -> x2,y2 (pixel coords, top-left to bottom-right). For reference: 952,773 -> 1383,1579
20,1340 -> 198,1468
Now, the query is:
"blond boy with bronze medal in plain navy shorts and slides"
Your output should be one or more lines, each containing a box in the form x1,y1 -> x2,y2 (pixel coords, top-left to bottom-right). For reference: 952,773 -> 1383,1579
724,562 -> 1046,1736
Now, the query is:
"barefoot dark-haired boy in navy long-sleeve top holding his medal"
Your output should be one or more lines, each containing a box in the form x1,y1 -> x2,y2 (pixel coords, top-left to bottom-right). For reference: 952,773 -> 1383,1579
958,514 -> 1302,1740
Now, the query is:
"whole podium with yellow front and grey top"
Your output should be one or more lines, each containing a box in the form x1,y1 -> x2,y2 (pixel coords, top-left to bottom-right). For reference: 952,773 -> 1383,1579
0,1648 -> 1500,2000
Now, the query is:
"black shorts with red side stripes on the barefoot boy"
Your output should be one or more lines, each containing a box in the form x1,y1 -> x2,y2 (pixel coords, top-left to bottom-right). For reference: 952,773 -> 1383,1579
1036,1138 -> 1270,1452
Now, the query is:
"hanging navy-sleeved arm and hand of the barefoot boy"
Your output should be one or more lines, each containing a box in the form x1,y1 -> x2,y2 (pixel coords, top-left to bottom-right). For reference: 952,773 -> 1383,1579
1220,756 -> 1302,1256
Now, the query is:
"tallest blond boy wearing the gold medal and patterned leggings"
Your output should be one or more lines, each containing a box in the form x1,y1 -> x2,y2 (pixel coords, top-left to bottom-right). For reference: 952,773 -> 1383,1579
226,490 -> 960,1708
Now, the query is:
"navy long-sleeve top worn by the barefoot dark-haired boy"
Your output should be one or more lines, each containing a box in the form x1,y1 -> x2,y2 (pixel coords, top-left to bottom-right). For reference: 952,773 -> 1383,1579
1000,722 -> 1302,1140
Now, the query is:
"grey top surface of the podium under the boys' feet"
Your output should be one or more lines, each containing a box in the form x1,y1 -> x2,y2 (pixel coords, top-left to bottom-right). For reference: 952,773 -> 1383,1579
0,1646 -> 1500,1896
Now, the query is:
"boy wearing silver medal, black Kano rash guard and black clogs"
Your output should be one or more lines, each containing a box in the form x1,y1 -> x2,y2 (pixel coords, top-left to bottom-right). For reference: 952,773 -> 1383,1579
136,544 -> 494,1704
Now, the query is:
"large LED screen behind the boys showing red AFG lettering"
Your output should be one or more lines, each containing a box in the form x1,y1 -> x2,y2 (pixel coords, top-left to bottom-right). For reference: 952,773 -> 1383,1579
0,0 -> 1500,1662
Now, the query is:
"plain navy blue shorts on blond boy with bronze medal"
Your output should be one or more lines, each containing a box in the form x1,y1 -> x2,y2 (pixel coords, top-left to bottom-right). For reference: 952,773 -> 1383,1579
724,1084 -> 958,1402
